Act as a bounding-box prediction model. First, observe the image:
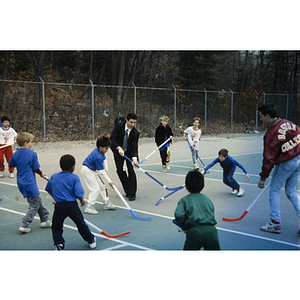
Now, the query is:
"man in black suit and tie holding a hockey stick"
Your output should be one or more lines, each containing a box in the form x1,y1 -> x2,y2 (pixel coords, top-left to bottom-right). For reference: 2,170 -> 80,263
110,113 -> 140,201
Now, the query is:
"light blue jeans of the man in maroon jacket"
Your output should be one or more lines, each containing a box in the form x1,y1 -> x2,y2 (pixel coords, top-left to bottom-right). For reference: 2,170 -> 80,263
269,155 -> 300,222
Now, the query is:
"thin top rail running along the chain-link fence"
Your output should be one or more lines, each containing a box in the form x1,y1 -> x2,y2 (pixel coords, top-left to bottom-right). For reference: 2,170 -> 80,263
0,78 -> 300,96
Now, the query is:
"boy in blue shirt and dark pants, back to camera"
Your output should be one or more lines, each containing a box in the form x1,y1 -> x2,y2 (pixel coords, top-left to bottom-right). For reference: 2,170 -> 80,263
46,154 -> 96,250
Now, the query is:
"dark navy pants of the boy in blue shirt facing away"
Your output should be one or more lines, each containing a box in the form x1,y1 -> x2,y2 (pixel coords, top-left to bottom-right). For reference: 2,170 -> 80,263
51,201 -> 94,245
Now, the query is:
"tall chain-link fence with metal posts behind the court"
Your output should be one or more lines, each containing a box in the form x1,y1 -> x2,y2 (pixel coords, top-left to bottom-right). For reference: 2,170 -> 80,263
0,79 -> 299,141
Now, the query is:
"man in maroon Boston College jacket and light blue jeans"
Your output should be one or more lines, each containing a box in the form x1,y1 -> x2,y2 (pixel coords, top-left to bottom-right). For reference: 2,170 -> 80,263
258,104 -> 300,234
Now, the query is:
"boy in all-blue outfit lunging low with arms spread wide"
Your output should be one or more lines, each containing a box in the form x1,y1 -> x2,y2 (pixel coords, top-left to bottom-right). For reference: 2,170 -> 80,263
201,149 -> 250,197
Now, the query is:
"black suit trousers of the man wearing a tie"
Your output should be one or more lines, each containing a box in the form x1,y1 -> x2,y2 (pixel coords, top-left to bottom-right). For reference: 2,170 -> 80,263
113,151 -> 137,195
